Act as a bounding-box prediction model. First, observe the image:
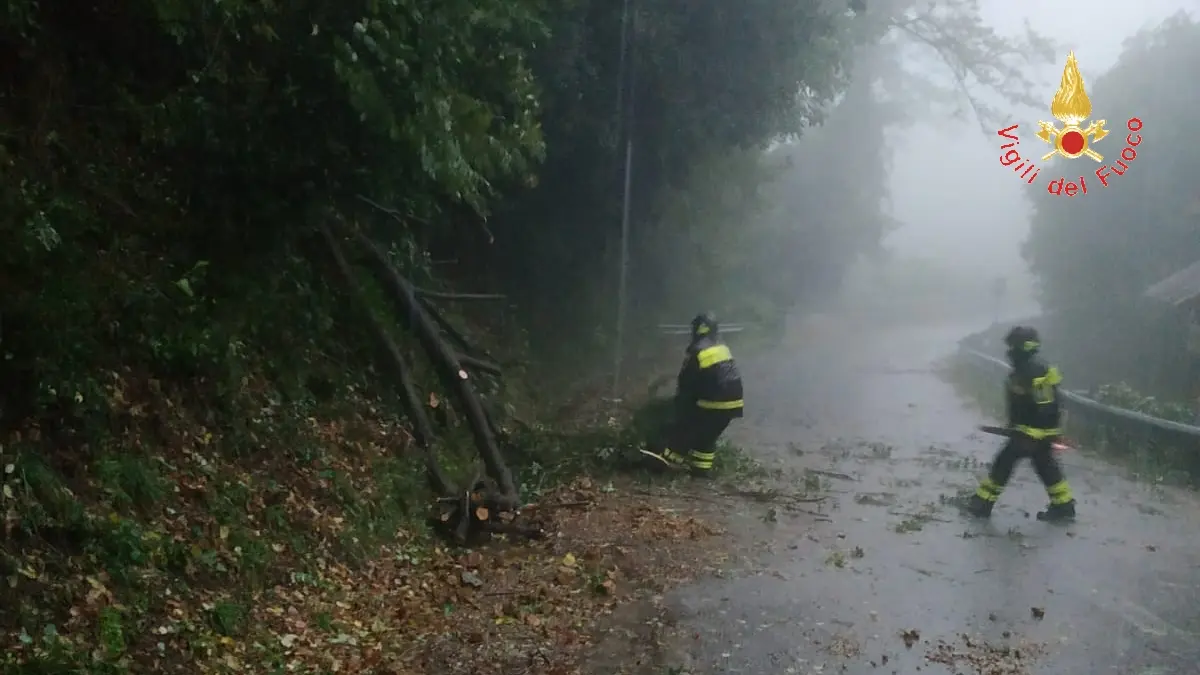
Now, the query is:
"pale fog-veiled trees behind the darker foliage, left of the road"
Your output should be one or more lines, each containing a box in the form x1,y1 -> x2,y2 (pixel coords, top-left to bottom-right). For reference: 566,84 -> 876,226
614,1 -> 1050,322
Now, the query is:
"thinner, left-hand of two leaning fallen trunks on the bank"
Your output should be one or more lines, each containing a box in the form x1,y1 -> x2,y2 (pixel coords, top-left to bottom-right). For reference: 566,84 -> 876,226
320,223 -> 457,496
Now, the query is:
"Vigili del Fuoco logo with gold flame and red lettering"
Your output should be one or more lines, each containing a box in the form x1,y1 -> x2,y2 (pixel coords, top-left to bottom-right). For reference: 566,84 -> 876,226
996,52 -> 1141,197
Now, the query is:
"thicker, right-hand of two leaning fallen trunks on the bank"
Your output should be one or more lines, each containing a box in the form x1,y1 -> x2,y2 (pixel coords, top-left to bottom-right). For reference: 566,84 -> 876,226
353,223 -> 520,510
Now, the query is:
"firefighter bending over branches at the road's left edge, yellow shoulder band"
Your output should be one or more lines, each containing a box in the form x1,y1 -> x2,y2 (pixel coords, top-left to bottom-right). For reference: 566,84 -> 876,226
658,313 -> 743,474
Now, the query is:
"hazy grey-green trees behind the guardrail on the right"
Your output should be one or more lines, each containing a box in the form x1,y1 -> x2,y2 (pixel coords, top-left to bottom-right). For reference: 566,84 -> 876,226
1025,13 -> 1200,395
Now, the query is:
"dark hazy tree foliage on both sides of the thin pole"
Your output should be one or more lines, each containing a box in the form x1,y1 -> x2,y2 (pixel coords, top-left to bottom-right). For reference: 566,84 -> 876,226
492,0 -> 854,348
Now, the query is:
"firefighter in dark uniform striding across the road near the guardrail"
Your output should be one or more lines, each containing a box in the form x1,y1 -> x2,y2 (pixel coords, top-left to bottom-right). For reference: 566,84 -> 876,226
968,325 -> 1075,521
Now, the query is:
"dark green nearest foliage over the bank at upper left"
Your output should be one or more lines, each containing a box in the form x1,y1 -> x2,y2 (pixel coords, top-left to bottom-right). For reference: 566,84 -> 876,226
0,0 -> 545,437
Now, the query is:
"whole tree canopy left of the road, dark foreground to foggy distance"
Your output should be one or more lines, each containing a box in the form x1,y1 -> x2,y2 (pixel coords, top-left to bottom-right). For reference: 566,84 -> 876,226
0,0 -> 1056,425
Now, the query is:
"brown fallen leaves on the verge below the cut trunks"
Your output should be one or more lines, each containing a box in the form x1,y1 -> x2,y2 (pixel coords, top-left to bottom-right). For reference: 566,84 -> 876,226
225,480 -> 719,675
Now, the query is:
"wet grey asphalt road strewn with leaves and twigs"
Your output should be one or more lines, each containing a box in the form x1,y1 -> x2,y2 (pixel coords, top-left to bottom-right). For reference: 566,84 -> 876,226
666,321 -> 1200,675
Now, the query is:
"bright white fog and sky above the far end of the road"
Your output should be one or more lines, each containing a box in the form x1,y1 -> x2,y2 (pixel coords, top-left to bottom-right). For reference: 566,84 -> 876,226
844,0 -> 1196,324
